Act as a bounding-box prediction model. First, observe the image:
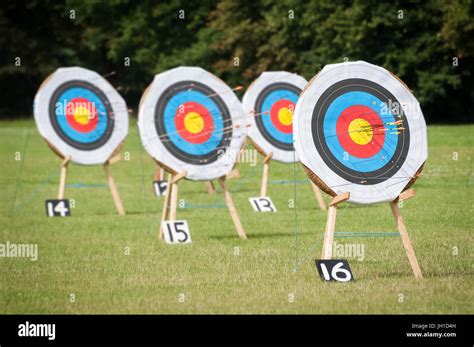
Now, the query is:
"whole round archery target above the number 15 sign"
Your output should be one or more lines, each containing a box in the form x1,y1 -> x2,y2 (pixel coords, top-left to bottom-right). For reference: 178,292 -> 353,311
138,67 -> 246,180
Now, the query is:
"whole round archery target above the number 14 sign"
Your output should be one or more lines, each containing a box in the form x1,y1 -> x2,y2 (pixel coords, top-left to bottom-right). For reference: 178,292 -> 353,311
34,67 -> 128,165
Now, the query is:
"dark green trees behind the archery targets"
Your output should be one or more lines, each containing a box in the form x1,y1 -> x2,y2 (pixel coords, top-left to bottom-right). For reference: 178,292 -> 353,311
0,0 -> 474,123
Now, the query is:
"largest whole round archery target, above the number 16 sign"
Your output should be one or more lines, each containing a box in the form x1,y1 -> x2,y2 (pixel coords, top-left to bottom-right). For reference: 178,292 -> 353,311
294,61 -> 428,204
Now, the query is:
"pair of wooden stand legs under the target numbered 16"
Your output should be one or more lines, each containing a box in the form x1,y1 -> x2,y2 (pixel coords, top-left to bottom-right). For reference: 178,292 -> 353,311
321,189 -> 423,279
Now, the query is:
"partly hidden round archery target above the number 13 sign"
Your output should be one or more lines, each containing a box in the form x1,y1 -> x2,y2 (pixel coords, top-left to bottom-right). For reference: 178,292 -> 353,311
242,71 -> 307,163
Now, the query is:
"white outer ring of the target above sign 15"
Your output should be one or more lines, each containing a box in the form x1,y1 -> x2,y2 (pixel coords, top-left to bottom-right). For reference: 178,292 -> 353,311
138,67 -> 247,180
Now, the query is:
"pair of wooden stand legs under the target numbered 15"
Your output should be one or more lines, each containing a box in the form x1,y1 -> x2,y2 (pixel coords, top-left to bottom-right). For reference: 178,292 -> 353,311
159,170 -> 247,240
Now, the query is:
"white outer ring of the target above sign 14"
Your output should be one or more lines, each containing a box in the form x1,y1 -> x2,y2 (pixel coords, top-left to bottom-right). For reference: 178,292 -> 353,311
33,67 -> 128,165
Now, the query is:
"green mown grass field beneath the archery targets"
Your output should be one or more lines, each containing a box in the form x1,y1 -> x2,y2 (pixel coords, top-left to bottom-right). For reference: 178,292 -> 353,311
0,120 -> 474,313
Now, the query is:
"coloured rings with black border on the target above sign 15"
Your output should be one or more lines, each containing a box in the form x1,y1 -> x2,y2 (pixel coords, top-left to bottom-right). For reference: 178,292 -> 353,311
155,81 -> 232,165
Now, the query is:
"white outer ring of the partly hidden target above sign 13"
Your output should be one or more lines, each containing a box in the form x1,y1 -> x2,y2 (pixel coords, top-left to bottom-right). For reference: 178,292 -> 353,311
242,71 -> 308,163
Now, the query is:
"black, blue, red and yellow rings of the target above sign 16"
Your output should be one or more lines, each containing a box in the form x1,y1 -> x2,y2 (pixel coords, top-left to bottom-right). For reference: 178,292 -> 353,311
311,79 -> 410,185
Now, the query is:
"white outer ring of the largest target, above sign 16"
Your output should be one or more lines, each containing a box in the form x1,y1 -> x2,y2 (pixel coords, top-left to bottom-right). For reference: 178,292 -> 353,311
293,61 -> 428,204
